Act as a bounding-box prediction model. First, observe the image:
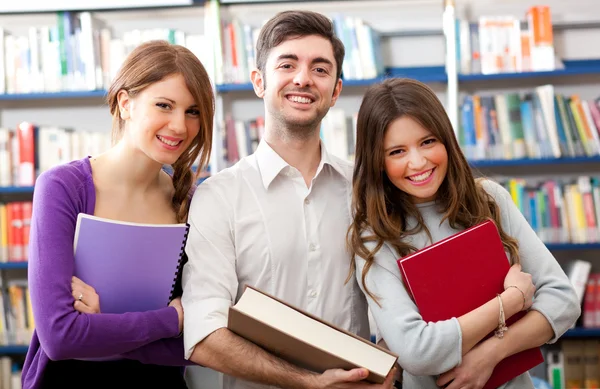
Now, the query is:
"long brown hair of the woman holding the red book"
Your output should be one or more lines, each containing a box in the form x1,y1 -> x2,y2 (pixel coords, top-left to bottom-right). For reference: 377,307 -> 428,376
347,78 -> 519,301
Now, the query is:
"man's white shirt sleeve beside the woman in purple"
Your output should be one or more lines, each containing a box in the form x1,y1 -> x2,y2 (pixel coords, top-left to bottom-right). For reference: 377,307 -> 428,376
181,175 -> 238,359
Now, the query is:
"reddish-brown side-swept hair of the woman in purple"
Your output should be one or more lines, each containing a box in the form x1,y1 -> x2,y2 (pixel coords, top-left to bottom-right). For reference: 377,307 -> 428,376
107,41 -> 215,222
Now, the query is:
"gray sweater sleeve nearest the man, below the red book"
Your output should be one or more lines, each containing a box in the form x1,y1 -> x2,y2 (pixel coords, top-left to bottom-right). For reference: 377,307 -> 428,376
356,245 -> 462,375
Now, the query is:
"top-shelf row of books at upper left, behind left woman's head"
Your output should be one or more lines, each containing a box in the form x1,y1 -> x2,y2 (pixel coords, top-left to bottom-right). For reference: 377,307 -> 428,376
0,11 -> 206,94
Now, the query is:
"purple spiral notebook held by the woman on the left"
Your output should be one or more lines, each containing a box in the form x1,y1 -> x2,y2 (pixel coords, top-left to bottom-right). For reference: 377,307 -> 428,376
73,213 -> 189,313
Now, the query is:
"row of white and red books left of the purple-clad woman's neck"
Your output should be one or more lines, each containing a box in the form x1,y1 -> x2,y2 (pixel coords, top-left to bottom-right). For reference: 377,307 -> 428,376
0,122 -> 111,187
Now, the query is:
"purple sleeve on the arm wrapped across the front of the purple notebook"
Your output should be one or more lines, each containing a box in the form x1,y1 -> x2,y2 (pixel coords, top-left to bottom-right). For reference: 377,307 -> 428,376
28,171 -> 179,360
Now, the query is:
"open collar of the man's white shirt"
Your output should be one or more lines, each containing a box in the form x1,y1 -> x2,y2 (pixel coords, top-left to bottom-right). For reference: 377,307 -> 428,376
254,140 -> 352,190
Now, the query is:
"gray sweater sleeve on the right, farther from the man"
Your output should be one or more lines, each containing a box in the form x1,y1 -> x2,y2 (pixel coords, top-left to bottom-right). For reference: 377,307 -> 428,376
484,181 -> 581,343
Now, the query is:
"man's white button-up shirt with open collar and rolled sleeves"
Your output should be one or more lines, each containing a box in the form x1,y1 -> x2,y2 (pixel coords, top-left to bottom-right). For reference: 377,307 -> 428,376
182,141 -> 369,389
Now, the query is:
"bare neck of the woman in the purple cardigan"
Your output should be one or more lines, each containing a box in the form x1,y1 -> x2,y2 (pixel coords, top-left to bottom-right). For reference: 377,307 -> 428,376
98,139 -> 162,192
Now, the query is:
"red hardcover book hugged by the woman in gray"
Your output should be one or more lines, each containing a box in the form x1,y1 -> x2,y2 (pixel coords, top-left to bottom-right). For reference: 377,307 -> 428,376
398,221 -> 544,389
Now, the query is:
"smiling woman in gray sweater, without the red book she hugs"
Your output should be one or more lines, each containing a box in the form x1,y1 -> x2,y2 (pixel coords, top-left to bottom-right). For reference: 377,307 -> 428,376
348,79 -> 580,389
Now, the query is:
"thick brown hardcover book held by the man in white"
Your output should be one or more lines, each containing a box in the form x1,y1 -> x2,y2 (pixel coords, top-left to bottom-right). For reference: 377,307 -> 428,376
227,286 -> 398,384
